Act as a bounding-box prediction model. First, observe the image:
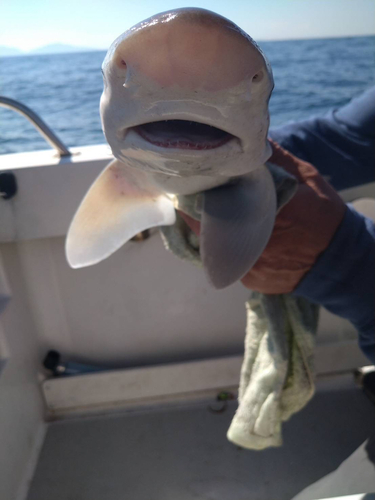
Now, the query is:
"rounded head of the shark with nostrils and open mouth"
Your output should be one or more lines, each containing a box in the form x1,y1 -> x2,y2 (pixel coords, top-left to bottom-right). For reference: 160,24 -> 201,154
100,8 -> 273,194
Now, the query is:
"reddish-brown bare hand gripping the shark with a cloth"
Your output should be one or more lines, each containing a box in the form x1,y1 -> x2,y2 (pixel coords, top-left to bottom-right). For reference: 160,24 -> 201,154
181,141 -> 346,294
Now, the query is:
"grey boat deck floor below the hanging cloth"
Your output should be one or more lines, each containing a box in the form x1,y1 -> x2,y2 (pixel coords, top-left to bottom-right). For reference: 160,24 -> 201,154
27,375 -> 375,500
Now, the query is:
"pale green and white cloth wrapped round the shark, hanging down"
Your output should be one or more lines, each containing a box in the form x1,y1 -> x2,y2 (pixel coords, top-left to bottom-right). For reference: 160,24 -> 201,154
161,163 -> 319,450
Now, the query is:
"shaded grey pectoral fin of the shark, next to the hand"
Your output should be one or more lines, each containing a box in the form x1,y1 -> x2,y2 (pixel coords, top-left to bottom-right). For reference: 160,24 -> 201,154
200,167 -> 276,289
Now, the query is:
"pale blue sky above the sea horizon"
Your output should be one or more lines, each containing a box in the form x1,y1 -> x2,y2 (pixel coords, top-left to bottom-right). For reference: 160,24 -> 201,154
0,0 -> 375,50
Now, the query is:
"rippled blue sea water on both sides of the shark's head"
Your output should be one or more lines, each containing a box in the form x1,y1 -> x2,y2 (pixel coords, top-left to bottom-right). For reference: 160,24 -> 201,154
0,36 -> 375,154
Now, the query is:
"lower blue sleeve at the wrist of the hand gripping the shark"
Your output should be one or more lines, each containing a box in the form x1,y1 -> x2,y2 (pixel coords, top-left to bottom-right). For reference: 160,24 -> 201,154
293,205 -> 375,364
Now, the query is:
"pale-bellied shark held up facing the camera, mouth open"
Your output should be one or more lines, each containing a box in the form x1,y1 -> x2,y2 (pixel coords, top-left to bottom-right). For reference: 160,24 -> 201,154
66,8 -> 277,289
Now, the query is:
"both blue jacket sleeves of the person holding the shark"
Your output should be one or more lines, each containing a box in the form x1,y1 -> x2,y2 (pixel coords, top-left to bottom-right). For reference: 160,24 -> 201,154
269,87 -> 375,364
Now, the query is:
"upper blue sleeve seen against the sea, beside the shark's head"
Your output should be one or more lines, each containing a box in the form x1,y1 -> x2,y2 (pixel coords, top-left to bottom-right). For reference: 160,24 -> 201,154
269,87 -> 375,191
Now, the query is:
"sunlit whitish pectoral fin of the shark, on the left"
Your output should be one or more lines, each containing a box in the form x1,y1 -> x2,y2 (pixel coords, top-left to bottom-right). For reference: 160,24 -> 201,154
66,160 -> 176,268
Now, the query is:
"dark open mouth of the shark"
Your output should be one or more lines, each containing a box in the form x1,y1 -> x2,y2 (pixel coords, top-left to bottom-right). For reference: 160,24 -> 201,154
133,120 -> 235,150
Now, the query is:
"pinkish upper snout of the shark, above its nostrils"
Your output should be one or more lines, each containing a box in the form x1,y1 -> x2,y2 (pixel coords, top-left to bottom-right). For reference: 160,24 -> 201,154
111,9 -> 264,91
